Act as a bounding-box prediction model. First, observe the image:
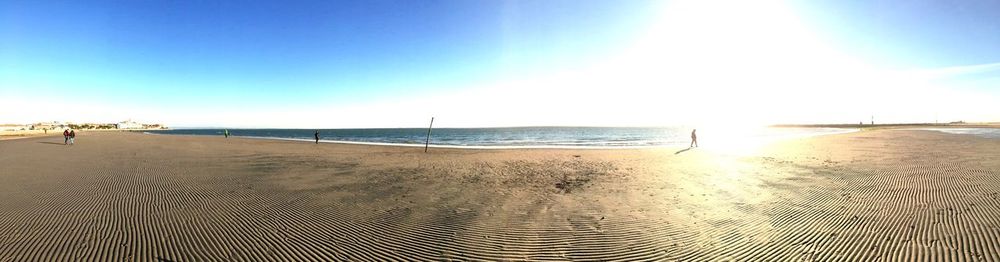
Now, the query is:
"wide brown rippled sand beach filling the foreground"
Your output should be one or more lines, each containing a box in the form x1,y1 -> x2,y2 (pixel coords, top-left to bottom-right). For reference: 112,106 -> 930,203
0,130 -> 1000,261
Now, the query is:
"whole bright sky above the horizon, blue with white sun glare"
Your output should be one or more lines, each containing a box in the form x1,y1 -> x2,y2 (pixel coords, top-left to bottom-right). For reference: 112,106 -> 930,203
0,0 -> 1000,128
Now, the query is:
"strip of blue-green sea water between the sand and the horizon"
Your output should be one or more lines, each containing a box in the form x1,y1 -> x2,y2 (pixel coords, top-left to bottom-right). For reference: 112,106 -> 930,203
149,127 -> 856,148
